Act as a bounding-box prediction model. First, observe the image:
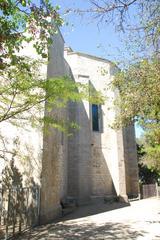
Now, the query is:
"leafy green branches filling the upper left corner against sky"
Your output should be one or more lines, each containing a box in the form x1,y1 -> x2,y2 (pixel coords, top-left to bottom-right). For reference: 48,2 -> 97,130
0,0 -> 63,69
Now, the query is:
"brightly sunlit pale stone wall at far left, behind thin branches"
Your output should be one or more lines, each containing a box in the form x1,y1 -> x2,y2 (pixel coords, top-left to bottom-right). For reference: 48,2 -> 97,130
0,37 -> 47,187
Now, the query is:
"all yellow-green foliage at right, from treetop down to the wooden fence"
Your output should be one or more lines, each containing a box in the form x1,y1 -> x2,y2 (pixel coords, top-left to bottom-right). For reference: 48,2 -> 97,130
112,58 -> 160,173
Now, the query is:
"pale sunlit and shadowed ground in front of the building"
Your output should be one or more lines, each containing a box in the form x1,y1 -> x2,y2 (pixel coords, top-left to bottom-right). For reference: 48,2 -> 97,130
18,198 -> 160,240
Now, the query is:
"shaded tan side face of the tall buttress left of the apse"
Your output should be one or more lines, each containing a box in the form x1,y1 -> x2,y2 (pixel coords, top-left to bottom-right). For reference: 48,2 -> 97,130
40,30 -> 68,223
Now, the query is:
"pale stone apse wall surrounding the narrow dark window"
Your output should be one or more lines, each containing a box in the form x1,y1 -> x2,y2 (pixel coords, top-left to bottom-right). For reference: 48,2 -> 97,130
65,49 -> 131,199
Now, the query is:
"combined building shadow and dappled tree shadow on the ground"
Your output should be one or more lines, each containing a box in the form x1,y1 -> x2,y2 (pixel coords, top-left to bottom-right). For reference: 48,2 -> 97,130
16,203 -> 148,240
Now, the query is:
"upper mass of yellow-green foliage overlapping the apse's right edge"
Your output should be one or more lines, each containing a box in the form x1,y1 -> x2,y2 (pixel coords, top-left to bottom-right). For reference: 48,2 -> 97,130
112,58 -> 160,129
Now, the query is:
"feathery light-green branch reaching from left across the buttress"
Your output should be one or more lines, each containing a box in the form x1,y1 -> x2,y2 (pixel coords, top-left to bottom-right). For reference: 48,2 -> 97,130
0,58 -> 103,130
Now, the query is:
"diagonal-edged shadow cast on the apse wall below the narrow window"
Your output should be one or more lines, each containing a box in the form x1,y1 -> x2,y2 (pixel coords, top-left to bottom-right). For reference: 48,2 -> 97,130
68,76 -> 117,201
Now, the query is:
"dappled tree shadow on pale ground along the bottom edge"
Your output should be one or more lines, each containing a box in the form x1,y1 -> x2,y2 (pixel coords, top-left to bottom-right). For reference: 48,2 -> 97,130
17,219 -> 145,240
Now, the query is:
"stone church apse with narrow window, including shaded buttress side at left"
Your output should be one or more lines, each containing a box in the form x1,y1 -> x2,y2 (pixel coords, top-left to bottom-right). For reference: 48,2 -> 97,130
40,33 -> 139,222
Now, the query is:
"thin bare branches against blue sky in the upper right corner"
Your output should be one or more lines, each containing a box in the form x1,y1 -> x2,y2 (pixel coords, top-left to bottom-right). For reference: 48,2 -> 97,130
88,0 -> 160,56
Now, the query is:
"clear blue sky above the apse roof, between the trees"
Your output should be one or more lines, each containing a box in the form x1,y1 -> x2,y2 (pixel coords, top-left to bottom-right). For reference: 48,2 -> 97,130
56,0 -> 125,61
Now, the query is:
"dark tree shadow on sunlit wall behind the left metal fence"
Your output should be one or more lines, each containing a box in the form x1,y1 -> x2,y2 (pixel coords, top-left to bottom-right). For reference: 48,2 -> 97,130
0,159 -> 39,239
